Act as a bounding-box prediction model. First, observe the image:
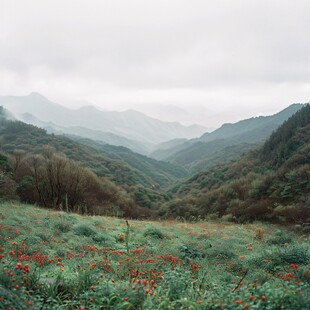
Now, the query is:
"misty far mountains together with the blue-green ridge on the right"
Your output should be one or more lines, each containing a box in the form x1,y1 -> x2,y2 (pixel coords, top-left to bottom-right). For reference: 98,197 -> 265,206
0,93 -> 303,174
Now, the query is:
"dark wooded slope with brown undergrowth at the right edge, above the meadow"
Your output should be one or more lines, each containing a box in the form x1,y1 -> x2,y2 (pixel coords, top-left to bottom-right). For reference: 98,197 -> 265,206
161,104 -> 310,222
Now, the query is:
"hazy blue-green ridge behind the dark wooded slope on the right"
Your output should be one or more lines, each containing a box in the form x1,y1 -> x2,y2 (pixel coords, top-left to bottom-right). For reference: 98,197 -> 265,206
150,104 -> 304,173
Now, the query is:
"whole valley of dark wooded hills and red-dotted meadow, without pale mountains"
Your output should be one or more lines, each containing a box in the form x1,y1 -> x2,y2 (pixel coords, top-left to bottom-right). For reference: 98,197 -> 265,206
0,100 -> 310,310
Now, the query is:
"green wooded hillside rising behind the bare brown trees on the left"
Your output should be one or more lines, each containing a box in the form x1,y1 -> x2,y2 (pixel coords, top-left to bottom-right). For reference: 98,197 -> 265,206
0,111 -> 186,212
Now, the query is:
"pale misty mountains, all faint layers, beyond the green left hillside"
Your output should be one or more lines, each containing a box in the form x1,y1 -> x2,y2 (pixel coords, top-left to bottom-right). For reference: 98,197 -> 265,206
0,93 -> 206,153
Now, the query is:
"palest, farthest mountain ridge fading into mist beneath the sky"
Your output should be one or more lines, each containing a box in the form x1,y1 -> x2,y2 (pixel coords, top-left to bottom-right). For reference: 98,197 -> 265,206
0,93 -> 206,145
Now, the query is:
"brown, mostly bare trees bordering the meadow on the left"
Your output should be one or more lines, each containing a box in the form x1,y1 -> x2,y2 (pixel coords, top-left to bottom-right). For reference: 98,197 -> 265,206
0,146 -> 154,218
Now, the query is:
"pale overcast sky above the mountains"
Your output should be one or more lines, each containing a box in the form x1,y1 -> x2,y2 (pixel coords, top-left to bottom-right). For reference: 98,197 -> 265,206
0,0 -> 310,127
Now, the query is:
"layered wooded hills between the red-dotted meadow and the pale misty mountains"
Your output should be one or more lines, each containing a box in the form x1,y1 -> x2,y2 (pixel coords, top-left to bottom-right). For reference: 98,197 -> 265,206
0,100 -> 310,223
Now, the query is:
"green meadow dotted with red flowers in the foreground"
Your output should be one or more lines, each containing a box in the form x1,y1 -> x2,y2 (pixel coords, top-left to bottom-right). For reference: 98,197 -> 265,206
0,203 -> 310,310
